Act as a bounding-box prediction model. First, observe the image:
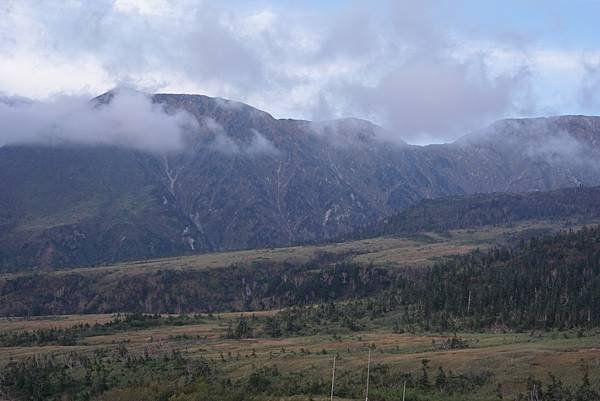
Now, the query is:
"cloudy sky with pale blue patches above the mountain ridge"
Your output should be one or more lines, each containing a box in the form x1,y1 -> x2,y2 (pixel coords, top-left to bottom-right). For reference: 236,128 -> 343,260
0,0 -> 600,143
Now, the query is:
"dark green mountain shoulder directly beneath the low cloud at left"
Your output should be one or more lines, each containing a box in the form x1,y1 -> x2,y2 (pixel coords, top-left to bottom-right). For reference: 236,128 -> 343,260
0,147 -> 209,267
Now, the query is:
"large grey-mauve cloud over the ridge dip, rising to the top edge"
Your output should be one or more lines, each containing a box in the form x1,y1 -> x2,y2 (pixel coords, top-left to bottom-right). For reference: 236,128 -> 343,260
313,1 -> 531,143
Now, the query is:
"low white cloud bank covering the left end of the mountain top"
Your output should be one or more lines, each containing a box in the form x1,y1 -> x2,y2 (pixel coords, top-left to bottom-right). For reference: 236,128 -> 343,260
0,90 -> 197,153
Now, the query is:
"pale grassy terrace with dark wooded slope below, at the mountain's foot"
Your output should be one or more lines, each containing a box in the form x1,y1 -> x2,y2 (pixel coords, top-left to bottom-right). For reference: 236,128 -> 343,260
0,219 -> 600,316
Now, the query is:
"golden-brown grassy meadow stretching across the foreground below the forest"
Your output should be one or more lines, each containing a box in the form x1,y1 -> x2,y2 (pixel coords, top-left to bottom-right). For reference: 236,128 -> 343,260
0,312 -> 600,400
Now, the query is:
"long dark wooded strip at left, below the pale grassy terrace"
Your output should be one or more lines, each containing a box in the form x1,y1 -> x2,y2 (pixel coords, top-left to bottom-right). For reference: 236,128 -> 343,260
0,261 -> 394,316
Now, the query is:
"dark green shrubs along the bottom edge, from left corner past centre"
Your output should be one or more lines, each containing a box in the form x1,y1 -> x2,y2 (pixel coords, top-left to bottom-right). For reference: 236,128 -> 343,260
0,345 -> 496,401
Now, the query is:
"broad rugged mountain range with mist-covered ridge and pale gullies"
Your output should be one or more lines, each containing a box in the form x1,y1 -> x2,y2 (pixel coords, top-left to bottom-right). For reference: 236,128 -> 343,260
0,92 -> 600,270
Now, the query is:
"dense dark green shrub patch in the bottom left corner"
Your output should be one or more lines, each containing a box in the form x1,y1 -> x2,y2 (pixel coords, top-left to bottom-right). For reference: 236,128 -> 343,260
0,344 -> 217,401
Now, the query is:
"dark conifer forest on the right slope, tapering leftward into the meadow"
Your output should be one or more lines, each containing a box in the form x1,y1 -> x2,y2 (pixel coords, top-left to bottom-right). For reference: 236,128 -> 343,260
261,227 -> 600,337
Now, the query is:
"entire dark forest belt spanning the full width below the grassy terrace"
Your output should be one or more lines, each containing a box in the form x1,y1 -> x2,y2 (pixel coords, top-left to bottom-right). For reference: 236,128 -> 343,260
0,227 -> 600,336
